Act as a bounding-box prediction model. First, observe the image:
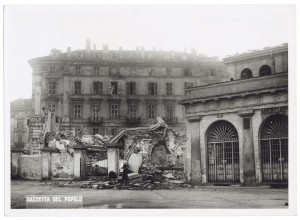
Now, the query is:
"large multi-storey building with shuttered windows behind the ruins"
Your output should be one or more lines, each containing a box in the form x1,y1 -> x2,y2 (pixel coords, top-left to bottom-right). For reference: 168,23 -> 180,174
29,39 -> 226,153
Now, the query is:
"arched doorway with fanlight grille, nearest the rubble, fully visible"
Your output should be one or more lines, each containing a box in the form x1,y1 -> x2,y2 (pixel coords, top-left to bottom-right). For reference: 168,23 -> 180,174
206,121 -> 240,182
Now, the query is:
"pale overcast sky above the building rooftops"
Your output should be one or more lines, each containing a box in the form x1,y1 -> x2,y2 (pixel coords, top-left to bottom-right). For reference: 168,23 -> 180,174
4,5 -> 293,100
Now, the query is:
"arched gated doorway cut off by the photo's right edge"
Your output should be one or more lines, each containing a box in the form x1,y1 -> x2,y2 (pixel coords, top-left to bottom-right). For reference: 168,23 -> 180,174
260,115 -> 288,182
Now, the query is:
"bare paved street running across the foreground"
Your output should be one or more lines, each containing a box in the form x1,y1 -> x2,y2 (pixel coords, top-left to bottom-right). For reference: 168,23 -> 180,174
11,181 -> 288,209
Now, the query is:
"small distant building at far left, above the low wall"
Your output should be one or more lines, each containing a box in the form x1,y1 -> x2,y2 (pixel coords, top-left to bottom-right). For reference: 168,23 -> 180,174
10,99 -> 32,148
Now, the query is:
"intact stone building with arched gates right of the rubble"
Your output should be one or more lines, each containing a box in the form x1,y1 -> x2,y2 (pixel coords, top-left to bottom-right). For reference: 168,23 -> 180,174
181,44 -> 288,185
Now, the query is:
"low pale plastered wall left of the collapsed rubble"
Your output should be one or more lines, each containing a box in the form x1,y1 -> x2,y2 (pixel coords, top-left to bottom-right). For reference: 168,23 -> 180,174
11,148 -> 87,180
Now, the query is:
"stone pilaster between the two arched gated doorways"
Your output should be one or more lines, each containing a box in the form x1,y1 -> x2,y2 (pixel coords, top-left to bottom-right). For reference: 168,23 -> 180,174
238,110 -> 256,185
